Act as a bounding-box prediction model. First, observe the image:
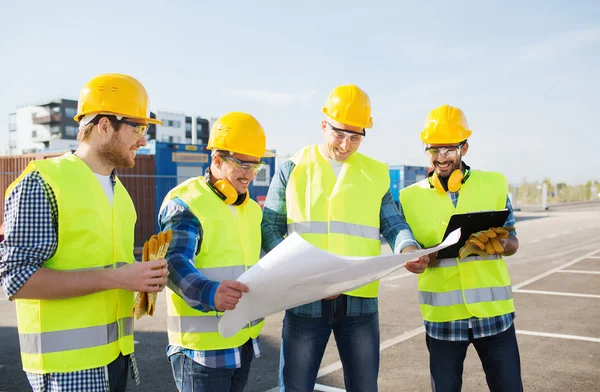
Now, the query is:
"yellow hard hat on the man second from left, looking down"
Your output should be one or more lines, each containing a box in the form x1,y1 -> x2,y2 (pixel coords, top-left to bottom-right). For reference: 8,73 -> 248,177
207,112 -> 275,158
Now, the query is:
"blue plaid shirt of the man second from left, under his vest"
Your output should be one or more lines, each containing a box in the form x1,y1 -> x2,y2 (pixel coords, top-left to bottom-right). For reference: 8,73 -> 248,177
158,198 -> 260,369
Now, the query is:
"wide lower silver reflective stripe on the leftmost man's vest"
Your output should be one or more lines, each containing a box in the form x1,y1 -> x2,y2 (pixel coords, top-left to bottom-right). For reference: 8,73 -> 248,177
19,317 -> 133,354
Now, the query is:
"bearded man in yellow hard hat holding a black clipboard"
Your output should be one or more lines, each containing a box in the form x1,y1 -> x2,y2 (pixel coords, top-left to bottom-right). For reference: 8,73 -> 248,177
400,105 -> 523,392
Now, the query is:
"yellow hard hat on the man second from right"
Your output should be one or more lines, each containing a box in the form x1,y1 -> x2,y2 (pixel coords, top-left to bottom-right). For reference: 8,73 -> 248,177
321,84 -> 373,128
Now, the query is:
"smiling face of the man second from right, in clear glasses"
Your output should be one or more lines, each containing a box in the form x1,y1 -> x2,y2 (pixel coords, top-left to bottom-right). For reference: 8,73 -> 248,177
321,119 -> 364,162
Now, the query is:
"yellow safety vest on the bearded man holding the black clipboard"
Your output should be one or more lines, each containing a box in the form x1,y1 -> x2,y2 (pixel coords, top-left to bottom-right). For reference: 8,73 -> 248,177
400,171 -> 515,322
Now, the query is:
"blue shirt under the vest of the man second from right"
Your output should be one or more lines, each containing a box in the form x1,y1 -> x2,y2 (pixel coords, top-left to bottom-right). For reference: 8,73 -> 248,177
262,160 -> 419,317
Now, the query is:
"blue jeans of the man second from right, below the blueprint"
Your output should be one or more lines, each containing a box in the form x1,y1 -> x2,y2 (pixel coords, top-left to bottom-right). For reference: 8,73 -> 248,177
279,296 -> 379,392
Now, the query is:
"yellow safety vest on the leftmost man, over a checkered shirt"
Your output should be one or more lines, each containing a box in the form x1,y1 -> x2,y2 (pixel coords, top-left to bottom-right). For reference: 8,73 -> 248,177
6,153 -> 137,374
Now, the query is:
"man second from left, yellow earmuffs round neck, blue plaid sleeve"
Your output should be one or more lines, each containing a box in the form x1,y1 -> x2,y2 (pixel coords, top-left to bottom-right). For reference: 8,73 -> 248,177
159,112 -> 274,392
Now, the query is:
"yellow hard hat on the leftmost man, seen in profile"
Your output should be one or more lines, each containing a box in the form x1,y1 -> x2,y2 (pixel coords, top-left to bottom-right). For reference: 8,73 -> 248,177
74,74 -> 163,124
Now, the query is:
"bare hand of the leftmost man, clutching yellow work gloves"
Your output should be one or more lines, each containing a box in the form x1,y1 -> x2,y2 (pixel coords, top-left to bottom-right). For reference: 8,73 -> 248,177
114,259 -> 169,293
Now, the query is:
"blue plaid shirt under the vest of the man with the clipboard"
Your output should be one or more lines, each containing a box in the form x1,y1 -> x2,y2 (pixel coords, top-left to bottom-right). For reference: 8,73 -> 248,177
400,178 -> 517,341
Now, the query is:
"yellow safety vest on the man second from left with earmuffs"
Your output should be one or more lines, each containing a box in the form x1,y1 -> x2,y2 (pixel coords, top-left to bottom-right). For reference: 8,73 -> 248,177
165,177 -> 264,350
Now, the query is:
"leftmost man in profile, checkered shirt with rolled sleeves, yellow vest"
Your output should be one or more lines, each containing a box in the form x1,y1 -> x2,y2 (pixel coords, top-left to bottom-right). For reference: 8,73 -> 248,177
0,74 -> 167,392
